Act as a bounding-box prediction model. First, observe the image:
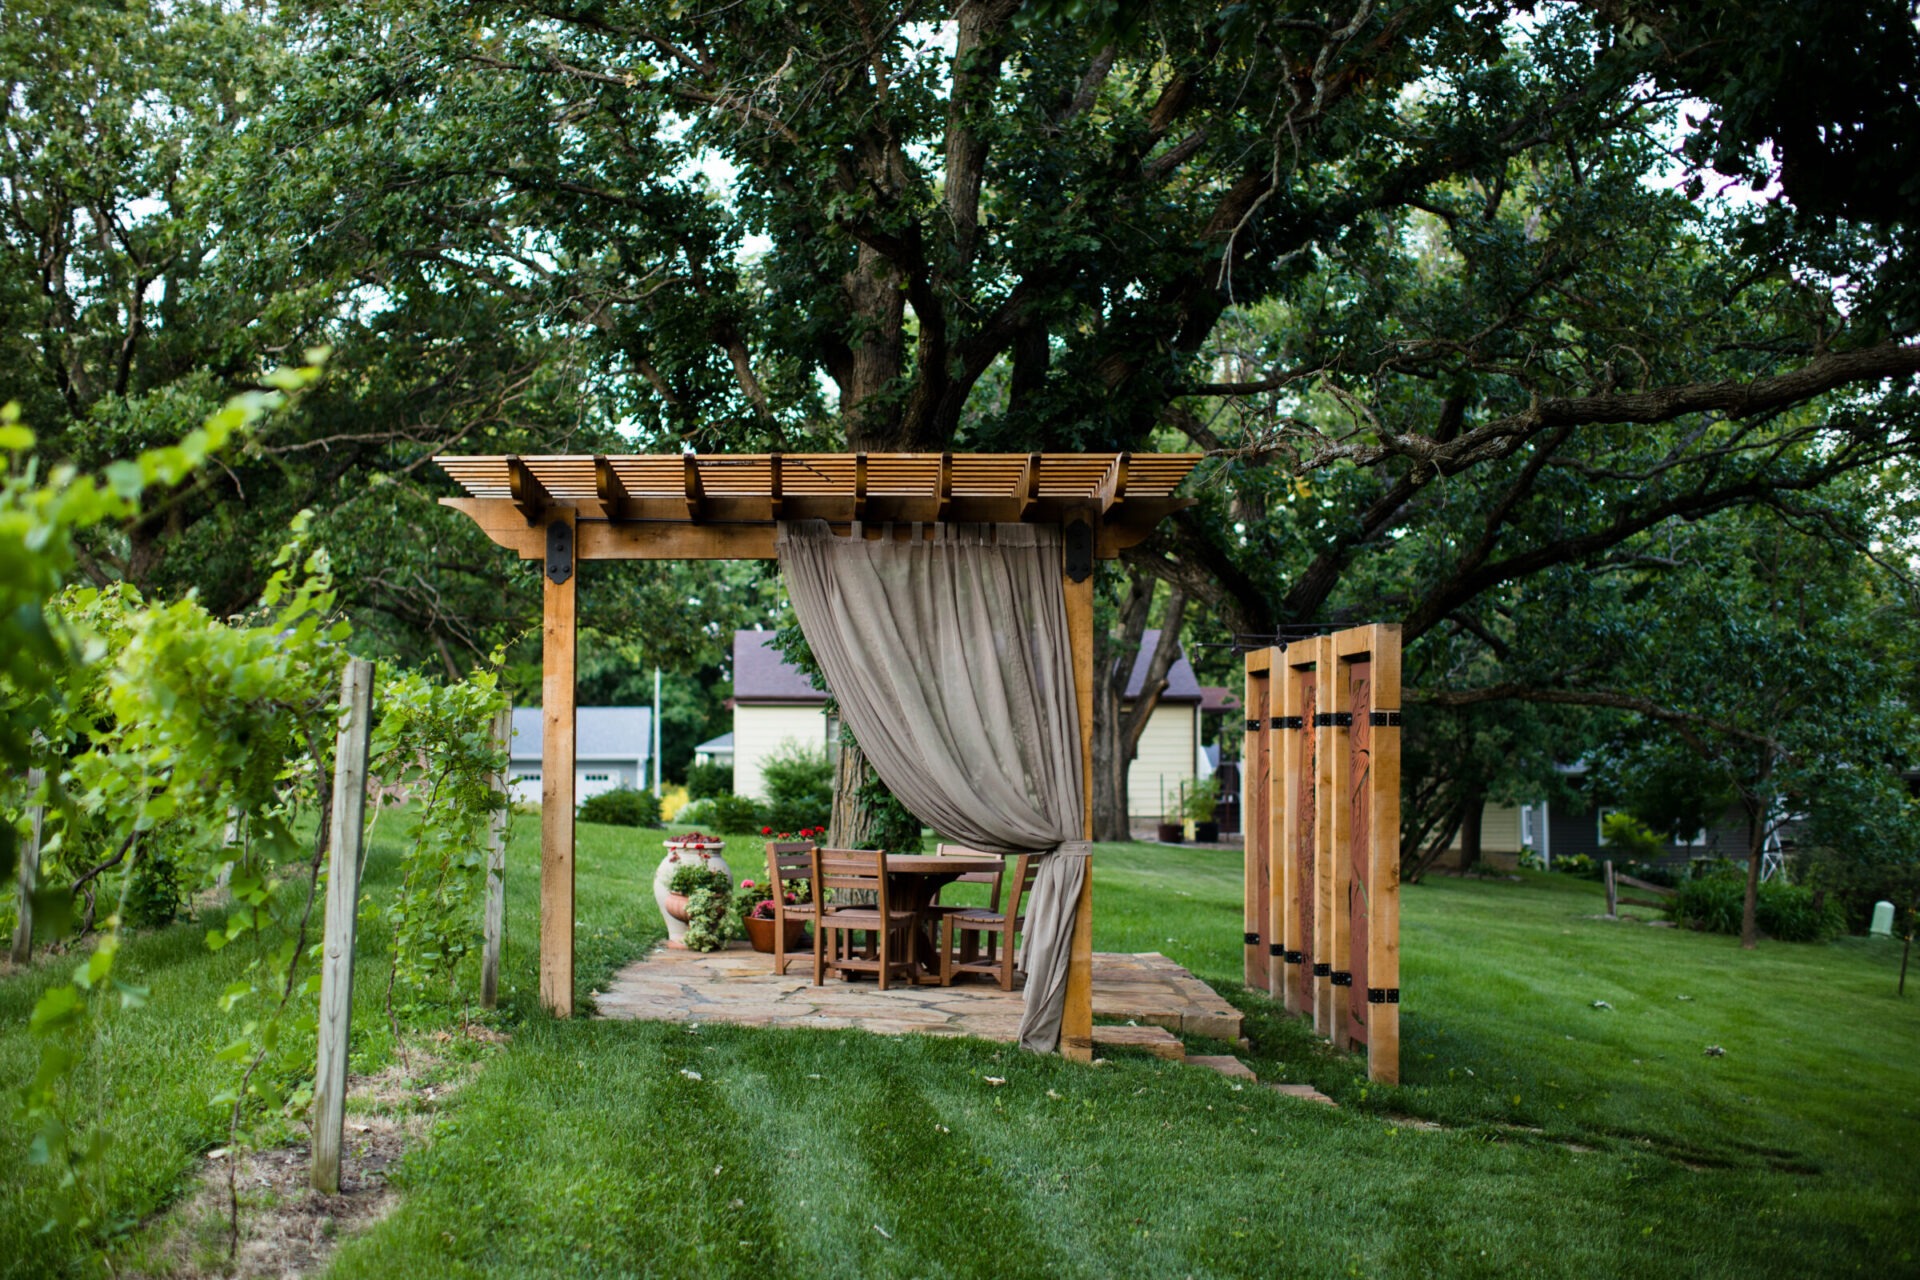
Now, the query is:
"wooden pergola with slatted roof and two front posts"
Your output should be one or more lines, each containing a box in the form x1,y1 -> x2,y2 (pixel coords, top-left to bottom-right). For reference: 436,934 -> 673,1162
434,453 -> 1200,1061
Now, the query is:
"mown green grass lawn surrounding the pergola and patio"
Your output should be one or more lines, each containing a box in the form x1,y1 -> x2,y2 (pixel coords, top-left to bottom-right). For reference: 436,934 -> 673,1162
0,821 -> 1920,1276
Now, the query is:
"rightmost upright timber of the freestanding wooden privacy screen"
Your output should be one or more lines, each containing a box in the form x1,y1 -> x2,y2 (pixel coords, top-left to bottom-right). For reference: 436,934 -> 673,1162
1367,624 -> 1400,1084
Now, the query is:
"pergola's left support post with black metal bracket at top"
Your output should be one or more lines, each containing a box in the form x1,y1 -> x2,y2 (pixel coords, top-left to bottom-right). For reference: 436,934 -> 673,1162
540,509 -> 580,1017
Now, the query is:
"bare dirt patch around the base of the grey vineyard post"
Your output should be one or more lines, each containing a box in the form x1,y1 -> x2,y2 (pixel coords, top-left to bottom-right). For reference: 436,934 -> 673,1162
123,1027 -> 505,1280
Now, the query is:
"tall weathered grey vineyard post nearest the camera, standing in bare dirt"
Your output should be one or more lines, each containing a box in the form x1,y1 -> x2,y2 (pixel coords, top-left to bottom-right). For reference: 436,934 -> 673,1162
313,658 -> 372,1196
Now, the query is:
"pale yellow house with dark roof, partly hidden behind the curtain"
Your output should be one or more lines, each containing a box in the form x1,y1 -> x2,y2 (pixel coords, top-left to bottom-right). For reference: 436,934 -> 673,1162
716,631 -> 1202,819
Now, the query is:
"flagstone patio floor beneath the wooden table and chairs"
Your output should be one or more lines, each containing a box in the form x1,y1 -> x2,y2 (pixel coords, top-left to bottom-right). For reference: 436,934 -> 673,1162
595,944 -> 1240,1057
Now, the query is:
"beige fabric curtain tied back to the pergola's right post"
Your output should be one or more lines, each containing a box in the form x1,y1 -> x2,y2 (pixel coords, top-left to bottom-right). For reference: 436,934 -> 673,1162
778,520 -> 1089,1052
